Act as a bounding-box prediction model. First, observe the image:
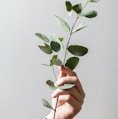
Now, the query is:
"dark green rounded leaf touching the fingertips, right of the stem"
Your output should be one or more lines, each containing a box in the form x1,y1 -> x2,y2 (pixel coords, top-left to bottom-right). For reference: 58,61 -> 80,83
65,57 -> 79,70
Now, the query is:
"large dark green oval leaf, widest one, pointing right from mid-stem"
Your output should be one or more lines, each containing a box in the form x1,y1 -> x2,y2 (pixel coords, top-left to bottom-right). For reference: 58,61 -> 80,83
68,45 -> 88,56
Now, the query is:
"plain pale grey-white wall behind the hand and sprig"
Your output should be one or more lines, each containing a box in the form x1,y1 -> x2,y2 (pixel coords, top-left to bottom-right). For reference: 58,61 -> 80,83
0,0 -> 118,119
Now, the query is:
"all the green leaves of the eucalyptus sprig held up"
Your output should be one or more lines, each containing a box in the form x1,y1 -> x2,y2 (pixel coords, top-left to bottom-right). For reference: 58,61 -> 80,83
35,0 -> 99,117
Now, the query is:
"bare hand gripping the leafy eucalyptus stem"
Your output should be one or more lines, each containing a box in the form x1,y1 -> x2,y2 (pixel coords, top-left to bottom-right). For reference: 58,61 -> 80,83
46,66 -> 85,119
